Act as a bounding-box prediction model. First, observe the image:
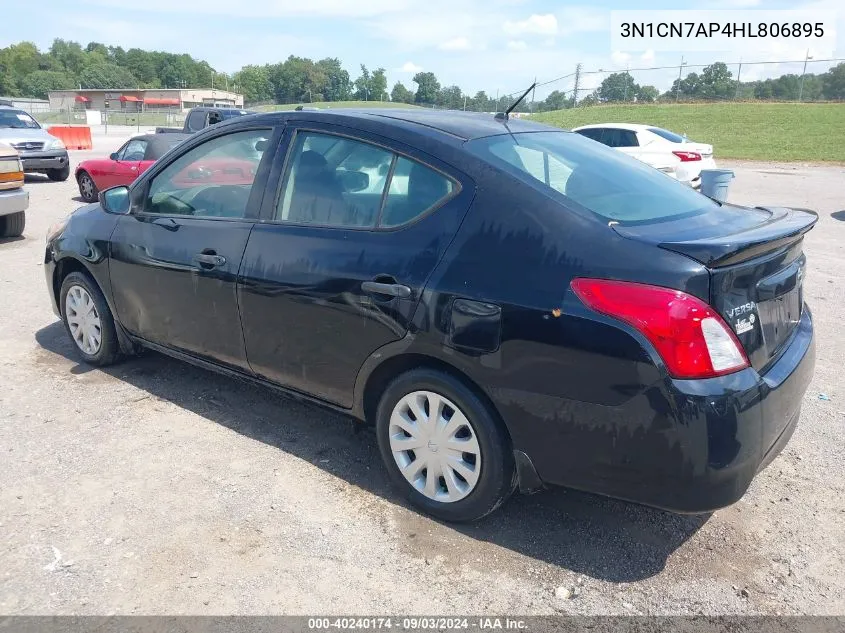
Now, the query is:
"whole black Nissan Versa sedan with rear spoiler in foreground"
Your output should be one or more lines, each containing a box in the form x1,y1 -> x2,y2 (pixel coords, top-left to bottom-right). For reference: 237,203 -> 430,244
44,110 -> 817,520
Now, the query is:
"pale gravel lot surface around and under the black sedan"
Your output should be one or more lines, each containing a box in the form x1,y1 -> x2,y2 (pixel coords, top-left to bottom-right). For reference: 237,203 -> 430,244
0,137 -> 845,614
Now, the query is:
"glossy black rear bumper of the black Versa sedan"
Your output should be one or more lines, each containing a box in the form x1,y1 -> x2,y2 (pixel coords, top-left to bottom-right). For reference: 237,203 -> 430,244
515,309 -> 815,513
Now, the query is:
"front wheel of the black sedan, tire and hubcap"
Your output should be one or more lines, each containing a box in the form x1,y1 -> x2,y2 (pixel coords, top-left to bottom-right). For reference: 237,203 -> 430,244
59,272 -> 120,366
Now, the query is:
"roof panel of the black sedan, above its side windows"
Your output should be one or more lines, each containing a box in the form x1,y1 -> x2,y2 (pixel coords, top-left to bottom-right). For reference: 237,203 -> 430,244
244,108 -> 565,142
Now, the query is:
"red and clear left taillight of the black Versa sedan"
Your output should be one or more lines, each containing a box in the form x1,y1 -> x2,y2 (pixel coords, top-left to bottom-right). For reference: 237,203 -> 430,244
572,279 -> 748,378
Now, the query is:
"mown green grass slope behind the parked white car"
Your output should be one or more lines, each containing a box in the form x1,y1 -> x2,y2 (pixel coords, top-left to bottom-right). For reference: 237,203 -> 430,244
531,103 -> 845,162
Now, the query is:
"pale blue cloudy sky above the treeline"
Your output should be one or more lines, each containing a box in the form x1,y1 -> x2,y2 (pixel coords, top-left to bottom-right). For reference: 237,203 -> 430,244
0,0 -> 845,98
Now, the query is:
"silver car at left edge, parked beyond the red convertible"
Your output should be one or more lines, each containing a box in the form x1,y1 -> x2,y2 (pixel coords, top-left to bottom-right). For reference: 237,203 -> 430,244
0,105 -> 70,180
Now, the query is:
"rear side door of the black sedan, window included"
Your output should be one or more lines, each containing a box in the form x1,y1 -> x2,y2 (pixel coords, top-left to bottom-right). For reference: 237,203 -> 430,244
239,125 -> 474,407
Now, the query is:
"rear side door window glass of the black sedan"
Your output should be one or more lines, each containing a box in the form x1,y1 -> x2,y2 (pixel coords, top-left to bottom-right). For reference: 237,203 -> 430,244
274,132 -> 457,228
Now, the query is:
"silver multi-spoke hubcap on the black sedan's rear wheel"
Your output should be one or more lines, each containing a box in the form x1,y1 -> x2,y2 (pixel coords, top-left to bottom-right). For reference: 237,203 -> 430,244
388,391 -> 481,503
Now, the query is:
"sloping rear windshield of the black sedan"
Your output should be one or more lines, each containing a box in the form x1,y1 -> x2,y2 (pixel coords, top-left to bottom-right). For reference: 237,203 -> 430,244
467,132 -> 717,224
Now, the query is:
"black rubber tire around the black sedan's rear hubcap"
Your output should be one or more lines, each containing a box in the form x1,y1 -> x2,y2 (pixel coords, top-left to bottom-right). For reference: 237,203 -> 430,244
376,368 -> 517,522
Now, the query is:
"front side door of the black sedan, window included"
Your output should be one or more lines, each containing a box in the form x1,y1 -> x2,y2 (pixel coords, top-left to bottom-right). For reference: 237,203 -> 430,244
110,124 -> 272,369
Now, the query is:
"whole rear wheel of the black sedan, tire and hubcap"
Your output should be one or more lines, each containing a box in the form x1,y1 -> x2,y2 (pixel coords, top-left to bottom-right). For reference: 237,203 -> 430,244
376,369 -> 516,521
